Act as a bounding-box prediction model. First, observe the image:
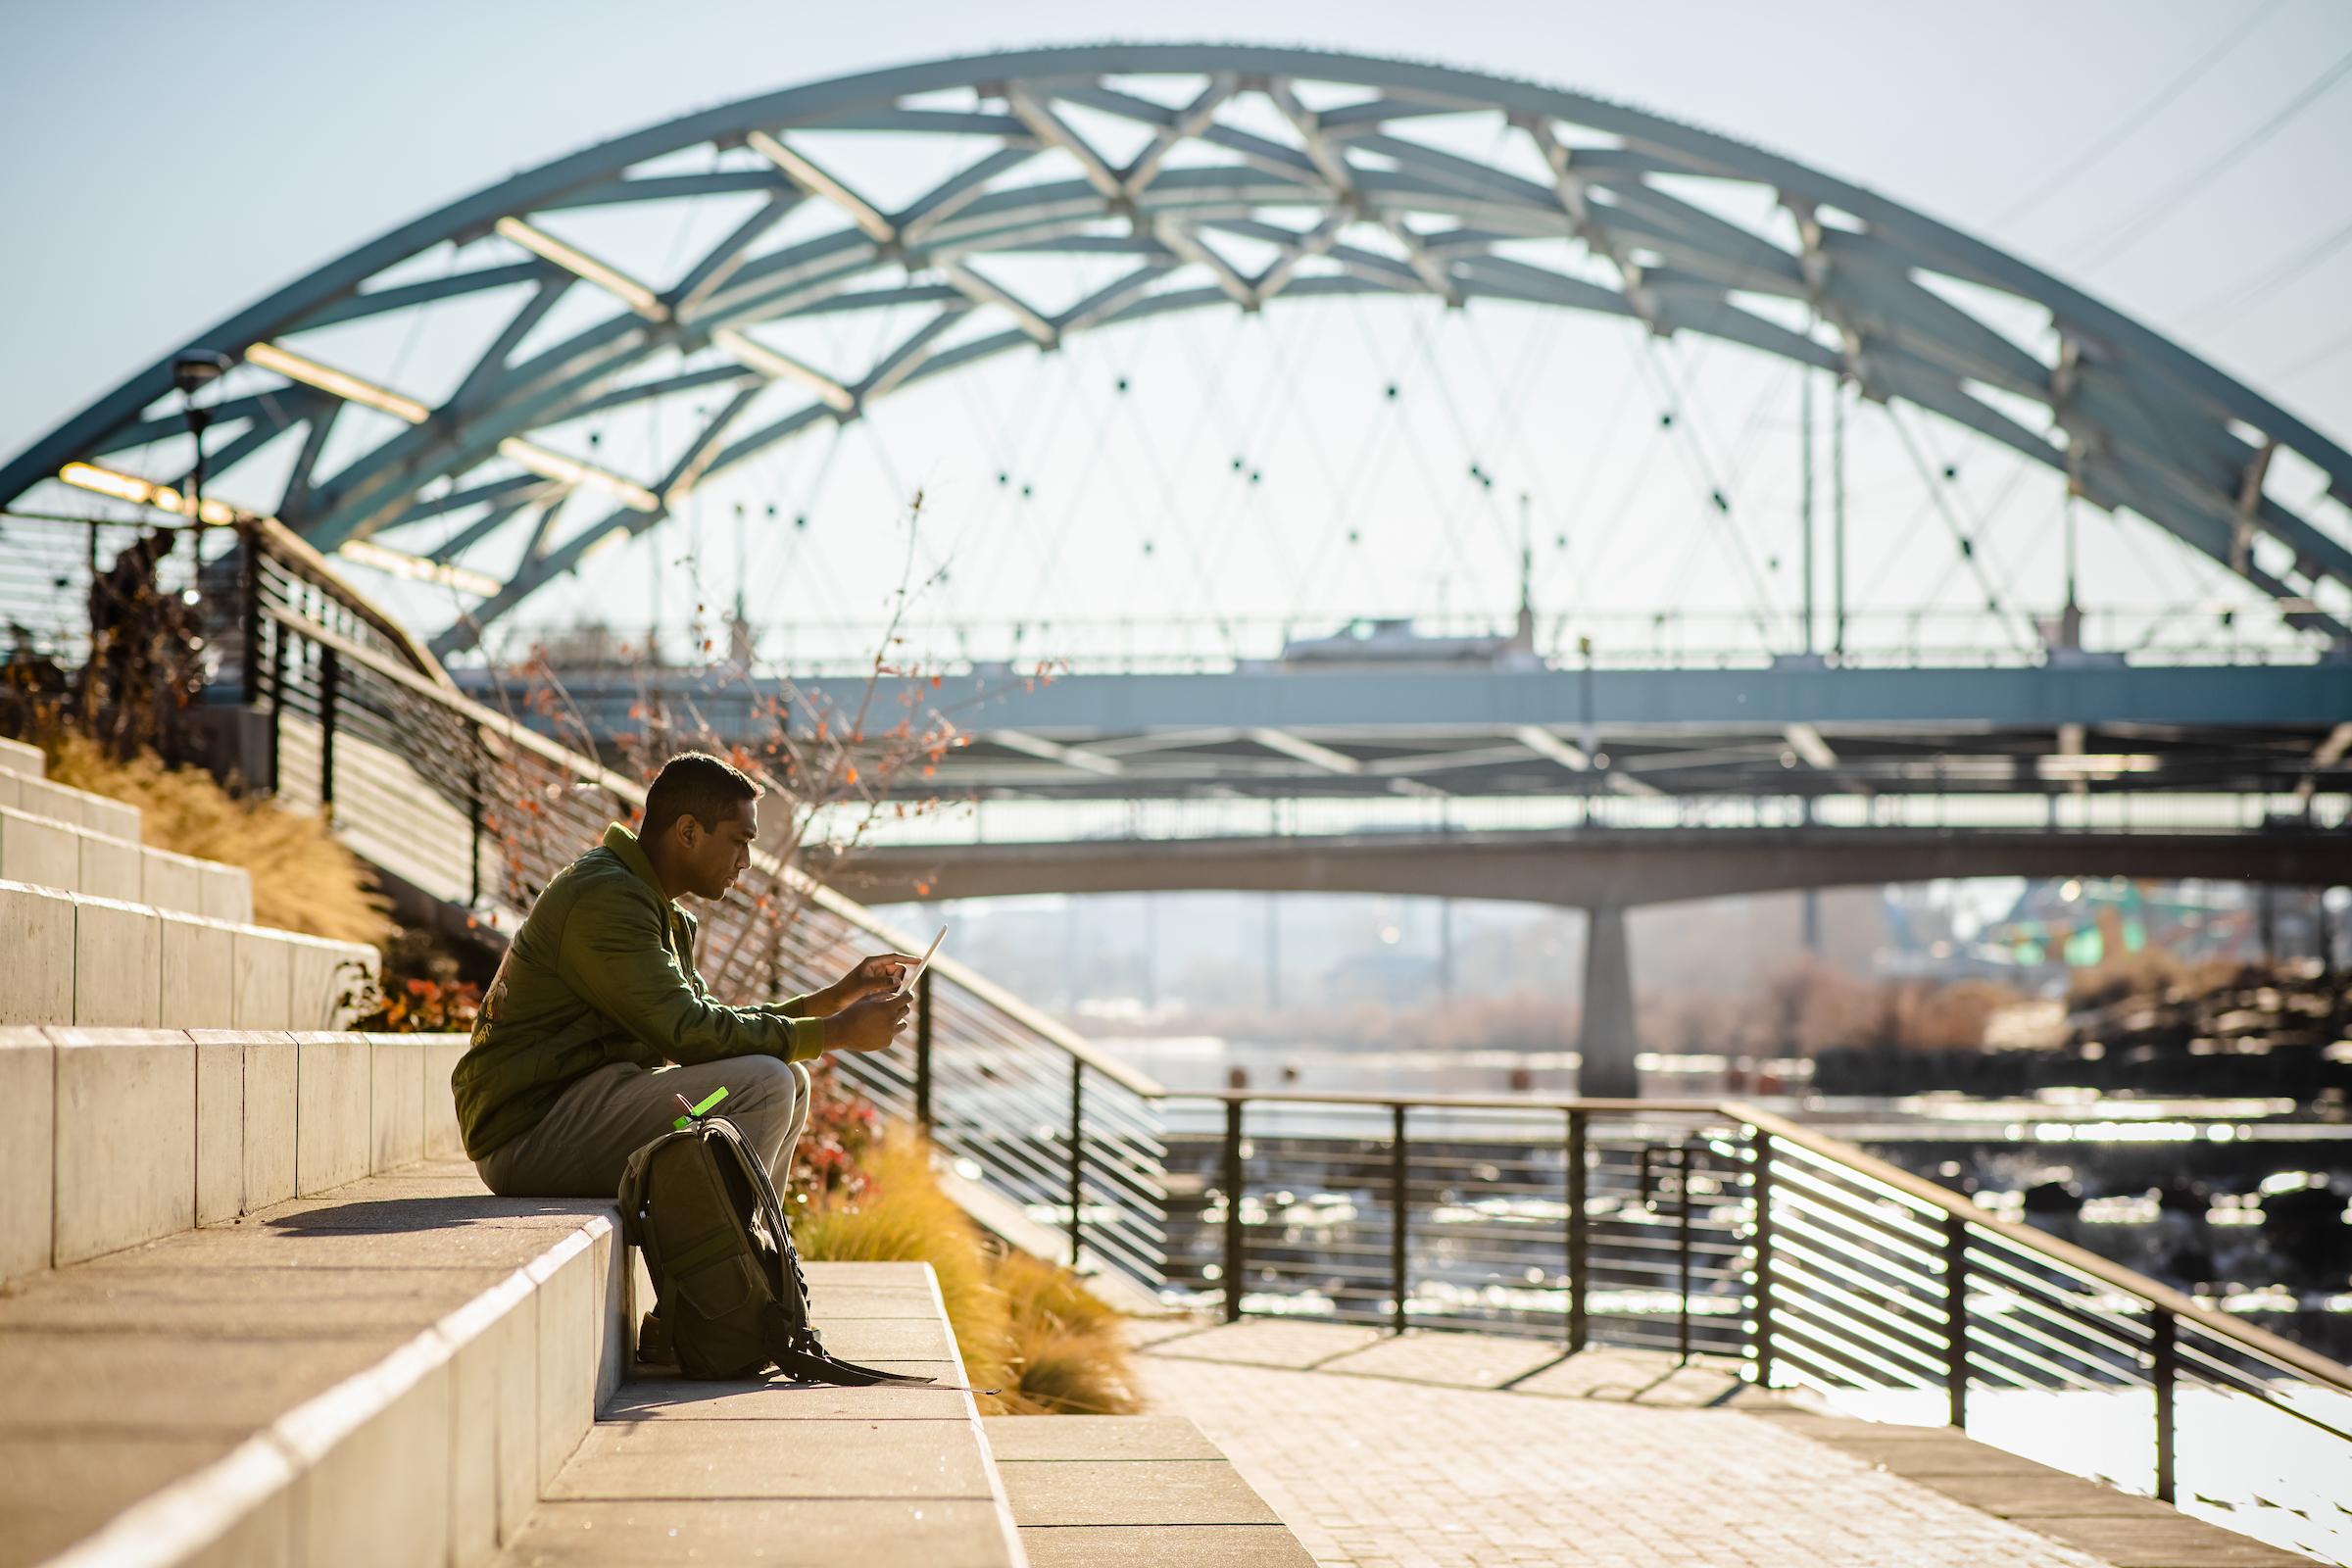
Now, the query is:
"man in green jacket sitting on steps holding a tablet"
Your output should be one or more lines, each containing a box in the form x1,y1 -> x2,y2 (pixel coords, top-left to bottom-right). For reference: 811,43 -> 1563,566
452,753 -> 915,1199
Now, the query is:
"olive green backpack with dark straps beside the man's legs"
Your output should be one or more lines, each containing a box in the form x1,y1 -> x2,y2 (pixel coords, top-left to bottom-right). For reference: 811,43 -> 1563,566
621,1109 -> 931,1385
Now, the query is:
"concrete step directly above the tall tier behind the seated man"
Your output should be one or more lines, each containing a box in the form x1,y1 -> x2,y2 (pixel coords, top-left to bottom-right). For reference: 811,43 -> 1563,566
0,882 -> 383,1030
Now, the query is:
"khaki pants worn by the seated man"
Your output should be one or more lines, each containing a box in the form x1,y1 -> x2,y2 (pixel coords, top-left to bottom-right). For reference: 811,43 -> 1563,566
472,1055 -> 809,1199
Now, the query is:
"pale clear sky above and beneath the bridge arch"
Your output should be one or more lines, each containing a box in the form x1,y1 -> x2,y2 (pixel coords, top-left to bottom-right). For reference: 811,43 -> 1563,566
0,0 -> 2352,662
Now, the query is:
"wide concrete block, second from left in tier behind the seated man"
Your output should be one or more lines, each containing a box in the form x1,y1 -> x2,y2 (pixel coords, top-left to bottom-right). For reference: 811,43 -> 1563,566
49,1027 -> 195,1267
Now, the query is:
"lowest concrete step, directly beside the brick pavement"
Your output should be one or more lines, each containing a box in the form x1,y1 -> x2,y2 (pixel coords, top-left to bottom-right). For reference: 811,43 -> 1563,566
983,1415 -> 1315,1568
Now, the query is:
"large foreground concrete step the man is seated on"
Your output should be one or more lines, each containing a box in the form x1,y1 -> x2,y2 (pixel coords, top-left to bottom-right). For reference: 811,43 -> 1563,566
0,1161 -> 628,1568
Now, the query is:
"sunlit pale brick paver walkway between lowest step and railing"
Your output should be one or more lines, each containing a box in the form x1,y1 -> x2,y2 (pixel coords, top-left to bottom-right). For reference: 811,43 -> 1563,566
1139,1348 -> 2100,1568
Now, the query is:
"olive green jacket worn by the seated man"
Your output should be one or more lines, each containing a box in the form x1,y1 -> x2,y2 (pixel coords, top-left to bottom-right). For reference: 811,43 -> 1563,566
449,823 -> 825,1159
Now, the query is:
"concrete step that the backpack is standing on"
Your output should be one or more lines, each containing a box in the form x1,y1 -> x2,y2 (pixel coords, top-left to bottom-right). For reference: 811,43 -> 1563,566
499,1262 -> 1025,1568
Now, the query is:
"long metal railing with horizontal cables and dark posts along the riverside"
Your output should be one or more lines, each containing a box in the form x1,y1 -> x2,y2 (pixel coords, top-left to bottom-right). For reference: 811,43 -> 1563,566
220,531 -> 2352,1542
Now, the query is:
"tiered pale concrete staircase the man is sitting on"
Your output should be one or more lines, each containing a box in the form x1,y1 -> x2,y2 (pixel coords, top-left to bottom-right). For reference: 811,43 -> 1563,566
0,745 -> 1336,1568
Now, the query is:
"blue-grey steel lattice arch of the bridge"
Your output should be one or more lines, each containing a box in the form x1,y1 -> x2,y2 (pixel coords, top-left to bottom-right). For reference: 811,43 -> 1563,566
0,45 -> 2352,651
